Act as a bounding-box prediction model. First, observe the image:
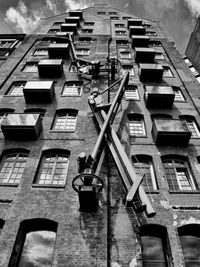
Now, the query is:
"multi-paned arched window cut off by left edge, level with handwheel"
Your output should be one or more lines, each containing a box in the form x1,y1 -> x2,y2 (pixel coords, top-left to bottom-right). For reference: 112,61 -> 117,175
0,151 -> 28,184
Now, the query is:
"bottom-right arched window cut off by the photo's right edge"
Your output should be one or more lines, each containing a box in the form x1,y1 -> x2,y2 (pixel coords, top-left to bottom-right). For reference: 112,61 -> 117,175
178,224 -> 200,267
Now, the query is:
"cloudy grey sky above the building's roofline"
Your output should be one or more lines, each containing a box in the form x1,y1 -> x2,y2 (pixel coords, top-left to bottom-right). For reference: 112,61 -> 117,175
0,0 -> 200,54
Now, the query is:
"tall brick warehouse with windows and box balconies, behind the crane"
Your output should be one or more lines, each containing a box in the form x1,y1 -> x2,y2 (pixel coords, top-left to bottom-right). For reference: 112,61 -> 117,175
0,4 -> 200,267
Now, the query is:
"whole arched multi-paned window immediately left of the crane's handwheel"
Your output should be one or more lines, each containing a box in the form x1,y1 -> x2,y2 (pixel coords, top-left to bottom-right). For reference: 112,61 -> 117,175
35,150 -> 70,186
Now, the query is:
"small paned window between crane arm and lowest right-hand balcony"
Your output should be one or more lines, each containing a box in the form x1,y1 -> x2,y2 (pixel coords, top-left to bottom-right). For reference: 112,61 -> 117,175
128,114 -> 146,136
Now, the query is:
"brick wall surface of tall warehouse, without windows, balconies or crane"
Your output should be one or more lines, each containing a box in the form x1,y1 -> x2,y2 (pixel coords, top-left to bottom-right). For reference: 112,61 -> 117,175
0,5 -> 200,267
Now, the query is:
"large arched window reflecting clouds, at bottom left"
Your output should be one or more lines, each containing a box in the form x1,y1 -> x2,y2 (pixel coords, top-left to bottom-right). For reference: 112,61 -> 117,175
8,219 -> 57,267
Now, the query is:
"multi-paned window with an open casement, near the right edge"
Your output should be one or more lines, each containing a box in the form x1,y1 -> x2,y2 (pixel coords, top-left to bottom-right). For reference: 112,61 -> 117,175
162,158 -> 196,192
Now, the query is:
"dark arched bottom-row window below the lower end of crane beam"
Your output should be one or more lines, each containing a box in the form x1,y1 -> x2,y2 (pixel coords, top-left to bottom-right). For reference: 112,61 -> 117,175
140,224 -> 171,267
